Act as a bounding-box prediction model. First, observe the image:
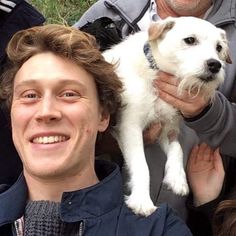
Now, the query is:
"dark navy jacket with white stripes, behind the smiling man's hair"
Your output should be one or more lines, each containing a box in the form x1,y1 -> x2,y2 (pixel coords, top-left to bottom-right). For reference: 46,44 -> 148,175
0,0 -> 45,184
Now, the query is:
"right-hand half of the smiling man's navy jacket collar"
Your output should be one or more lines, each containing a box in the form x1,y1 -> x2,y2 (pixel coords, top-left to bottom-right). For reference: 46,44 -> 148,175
61,160 -> 123,222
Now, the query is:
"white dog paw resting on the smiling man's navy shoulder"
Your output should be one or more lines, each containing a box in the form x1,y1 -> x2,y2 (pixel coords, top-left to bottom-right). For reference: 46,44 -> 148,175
125,194 -> 157,217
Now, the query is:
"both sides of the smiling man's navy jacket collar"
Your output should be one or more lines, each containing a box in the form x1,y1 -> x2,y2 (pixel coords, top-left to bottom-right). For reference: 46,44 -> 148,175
0,161 -> 123,226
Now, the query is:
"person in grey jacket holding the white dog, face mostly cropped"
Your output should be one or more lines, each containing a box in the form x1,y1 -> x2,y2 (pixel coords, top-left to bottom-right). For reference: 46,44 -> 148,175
74,0 -> 236,219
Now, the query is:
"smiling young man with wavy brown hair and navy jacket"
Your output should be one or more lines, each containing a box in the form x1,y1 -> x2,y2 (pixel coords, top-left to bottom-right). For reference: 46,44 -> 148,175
0,25 -> 191,236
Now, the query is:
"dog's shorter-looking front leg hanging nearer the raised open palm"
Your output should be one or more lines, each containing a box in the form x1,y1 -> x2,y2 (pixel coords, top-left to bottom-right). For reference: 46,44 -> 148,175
160,128 -> 189,196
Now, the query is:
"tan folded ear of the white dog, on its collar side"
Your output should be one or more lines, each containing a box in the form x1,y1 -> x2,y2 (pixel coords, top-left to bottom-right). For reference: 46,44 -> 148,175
148,21 -> 175,41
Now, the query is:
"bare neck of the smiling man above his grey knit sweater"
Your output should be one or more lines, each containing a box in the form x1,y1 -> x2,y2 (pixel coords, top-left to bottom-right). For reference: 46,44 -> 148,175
24,168 -> 99,202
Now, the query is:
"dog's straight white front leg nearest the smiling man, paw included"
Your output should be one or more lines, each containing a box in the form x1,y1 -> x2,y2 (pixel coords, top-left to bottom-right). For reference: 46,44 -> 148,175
117,114 -> 156,216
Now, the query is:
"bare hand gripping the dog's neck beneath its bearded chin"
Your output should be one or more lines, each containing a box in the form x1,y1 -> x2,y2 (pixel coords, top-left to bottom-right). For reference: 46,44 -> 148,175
154,71 -> 210,118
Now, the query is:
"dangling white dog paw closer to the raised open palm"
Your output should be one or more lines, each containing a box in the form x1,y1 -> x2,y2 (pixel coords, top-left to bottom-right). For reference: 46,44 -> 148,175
163,170 -> 189,196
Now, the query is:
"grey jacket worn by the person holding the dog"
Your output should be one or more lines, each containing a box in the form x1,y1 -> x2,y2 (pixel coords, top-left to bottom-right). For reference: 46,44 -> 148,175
75,0 -> 236,218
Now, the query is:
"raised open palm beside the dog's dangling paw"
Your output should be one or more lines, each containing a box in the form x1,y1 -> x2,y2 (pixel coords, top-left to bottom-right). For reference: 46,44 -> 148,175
187,143 -> 225,206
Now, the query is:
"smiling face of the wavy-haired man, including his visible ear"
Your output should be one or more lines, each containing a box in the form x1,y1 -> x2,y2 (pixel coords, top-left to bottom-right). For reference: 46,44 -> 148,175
11,52 -> 109,178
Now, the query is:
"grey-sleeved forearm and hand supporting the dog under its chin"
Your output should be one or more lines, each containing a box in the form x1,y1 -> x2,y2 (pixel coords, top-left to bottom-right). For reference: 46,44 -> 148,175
155,73 -> 236,156
